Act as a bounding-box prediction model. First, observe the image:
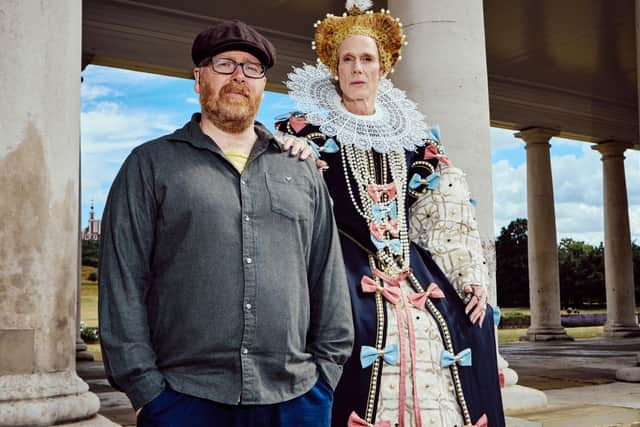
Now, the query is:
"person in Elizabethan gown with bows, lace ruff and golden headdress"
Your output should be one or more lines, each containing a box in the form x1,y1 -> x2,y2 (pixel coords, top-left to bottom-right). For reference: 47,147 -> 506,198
276,0 -> 505,427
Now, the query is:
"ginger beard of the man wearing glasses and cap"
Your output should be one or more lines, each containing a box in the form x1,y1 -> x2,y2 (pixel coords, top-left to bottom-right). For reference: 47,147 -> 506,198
200,81 -> 262,133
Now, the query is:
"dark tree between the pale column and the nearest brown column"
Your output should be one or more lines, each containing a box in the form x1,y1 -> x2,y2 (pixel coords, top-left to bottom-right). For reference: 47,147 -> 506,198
496,218 -> 529,307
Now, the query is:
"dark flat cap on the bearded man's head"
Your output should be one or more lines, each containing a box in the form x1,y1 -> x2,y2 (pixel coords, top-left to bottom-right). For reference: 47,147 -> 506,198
191,19 -> 276,68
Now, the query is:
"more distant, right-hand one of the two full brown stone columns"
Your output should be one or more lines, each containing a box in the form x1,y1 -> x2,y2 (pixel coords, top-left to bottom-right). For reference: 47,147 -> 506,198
592,141 -> 640,337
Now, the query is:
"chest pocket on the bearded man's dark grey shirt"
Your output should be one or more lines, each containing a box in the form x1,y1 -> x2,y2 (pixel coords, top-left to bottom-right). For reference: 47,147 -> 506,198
265,172 -> 313,221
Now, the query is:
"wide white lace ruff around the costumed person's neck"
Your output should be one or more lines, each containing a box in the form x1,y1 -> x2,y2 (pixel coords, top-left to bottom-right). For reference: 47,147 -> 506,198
285,64 -> 429,153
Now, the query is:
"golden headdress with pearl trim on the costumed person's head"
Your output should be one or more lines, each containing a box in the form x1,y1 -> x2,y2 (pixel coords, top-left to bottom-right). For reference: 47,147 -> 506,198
311,0 -> 407,74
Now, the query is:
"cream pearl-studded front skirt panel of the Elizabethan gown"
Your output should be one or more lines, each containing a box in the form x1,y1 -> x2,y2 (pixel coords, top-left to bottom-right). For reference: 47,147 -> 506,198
376,280 -> 464,427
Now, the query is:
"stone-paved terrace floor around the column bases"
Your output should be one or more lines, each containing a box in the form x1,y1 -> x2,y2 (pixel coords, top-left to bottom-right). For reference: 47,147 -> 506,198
78,338 -> 640,427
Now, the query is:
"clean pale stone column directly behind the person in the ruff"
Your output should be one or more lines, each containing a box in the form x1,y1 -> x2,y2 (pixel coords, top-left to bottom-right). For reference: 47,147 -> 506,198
388,0 -> 547,409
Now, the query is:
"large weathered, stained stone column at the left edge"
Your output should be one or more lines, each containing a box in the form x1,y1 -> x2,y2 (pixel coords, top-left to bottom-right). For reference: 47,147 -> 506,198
0,0 -> 104,426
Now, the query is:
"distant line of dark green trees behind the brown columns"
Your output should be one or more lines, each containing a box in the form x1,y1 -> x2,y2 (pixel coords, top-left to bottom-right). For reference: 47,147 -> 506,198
496,218 -> 640,309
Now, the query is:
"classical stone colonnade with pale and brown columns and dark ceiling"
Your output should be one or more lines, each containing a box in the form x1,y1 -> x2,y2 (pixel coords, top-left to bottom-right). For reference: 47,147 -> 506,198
0,0 -> 640,426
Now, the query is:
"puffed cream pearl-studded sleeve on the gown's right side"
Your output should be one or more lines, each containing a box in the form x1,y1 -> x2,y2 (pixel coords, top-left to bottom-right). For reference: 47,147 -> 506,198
409,166 -> 489,298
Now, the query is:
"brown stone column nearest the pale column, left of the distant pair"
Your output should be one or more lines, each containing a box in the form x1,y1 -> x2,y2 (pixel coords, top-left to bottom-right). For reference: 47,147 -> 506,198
515,128 -> 571,341
